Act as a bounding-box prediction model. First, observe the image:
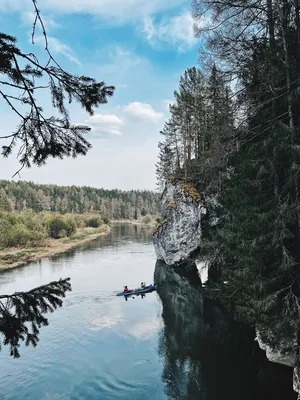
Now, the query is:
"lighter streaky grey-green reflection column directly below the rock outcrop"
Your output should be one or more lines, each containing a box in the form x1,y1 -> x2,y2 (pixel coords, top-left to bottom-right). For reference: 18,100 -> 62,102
155,262 -> 205,399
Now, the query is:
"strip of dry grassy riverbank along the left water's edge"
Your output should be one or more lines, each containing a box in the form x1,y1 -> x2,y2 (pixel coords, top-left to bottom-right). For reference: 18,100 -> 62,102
0,225 -> 110,271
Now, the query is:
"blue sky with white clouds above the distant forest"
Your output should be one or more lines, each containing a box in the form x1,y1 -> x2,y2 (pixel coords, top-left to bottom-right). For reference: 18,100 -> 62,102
0,0 -> 199,190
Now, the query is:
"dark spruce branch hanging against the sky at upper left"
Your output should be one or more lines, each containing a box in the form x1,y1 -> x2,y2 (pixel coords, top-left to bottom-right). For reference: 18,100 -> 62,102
0,0 -> 114,169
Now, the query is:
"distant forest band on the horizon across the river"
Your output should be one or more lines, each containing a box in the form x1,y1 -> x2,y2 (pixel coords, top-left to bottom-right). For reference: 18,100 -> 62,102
0,180 -> 158,220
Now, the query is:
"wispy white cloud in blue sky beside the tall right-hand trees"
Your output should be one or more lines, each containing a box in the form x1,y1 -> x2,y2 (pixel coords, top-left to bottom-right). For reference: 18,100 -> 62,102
142,12 -> 197,53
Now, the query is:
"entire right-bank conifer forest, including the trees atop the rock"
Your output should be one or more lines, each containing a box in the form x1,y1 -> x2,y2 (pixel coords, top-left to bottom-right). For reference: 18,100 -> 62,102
156,0 -> 300,347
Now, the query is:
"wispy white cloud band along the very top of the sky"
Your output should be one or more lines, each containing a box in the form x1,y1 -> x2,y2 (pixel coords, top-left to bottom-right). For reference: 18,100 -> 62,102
0,0 -> 186,23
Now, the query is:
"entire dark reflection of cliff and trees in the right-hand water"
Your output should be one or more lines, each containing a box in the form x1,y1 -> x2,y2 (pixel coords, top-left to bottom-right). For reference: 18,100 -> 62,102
155,261 -> 296,400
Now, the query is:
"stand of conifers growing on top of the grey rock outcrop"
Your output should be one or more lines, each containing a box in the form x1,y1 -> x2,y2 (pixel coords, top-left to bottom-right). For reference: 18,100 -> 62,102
156,65 -> 236,194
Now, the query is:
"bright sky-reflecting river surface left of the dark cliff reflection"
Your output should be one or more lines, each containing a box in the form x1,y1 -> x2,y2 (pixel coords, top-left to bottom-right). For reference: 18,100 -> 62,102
0,225 -> 167,400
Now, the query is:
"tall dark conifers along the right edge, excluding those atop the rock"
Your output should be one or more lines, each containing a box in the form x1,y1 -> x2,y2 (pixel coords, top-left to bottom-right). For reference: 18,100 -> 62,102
188,0 -> 300,351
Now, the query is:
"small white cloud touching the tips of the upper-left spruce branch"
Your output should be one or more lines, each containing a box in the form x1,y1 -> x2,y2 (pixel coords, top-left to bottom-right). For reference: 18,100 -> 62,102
86,114 -> 124,136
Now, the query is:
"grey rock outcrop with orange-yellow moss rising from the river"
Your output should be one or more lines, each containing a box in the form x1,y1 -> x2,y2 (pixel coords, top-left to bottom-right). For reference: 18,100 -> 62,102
153,182 -> 206,265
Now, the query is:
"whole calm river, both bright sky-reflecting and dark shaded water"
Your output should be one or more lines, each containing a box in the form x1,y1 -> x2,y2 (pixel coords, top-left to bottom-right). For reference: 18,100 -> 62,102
0,224 -> 295,400
